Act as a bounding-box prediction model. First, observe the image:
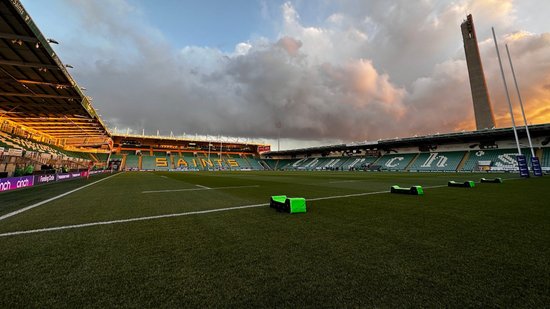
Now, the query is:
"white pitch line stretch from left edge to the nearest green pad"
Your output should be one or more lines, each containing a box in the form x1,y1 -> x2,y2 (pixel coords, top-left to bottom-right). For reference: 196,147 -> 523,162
0,203 -> 269,237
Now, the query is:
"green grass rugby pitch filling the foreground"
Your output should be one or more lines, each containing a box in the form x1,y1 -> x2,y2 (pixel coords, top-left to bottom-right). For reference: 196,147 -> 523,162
0,172 -> 550,308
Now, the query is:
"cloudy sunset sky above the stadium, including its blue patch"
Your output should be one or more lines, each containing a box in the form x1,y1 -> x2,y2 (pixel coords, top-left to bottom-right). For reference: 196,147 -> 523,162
22,0 -> 550,149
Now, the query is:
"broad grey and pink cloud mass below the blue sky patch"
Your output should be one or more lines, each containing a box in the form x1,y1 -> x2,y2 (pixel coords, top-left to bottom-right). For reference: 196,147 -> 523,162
48,0 -> 550,141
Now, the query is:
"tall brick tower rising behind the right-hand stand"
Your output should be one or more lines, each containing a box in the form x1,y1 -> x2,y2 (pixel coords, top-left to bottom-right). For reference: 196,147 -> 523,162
460,14 -> 495,130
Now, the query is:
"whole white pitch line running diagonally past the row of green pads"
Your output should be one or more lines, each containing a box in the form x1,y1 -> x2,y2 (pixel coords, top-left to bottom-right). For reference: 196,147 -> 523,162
0,185 -> 447,237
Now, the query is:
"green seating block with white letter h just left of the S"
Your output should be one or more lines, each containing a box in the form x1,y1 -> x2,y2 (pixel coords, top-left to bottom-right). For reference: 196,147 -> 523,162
409,151 -> 466,172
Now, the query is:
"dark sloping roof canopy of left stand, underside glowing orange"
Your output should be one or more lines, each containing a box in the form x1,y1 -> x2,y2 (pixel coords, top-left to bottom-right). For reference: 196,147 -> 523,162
0,0 -> 110,146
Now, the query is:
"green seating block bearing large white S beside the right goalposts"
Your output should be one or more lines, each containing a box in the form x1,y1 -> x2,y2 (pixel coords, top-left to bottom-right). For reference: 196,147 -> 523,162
462,149 -> 531,171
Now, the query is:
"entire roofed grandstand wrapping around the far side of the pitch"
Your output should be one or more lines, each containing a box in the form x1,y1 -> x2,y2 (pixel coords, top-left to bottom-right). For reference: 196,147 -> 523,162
0,2 -> 550,175
